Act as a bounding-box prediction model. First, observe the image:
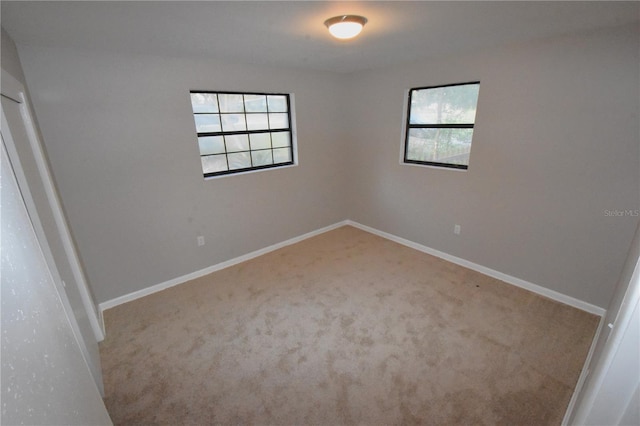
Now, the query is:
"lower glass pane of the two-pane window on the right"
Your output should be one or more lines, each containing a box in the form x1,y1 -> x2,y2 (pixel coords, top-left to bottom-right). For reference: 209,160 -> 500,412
407,129 -> 473,165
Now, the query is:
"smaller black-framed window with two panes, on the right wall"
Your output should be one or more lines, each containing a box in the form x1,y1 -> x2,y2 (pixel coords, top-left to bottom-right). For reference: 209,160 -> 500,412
404,82 -> 480,170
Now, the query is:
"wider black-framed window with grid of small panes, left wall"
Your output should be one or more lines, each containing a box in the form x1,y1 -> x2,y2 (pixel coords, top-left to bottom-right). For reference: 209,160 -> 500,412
191,91 -> 294,177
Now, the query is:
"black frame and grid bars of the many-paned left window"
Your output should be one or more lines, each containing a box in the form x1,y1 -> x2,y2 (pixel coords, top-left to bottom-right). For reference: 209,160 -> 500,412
189,90 -> 296,178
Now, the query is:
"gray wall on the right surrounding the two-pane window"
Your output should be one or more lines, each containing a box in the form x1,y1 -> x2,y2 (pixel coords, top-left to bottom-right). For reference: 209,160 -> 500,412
349,27 -> 640,307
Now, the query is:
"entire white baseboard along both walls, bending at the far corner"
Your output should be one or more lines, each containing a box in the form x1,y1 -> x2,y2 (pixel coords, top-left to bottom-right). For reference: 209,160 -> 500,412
99,220 -> 606,316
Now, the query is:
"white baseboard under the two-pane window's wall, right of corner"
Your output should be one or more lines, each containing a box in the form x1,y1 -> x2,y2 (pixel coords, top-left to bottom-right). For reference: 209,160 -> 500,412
346,220 -> 606,317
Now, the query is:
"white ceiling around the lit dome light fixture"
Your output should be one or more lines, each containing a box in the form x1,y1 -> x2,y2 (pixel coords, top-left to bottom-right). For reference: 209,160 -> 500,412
1,0 -> 640,72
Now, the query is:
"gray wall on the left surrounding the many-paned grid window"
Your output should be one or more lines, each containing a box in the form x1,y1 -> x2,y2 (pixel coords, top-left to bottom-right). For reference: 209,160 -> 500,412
18,46 -> 348,302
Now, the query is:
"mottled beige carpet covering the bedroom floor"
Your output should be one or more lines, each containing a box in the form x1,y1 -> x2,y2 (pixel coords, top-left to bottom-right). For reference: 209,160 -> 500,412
100,227 -> 598,425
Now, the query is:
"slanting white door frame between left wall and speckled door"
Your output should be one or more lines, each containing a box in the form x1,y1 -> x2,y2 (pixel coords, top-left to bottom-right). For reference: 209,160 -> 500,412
0,70 -> 104,393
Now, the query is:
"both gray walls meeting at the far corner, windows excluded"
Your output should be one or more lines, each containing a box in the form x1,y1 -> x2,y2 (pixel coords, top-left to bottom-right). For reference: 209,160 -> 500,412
13,24 -> 640,307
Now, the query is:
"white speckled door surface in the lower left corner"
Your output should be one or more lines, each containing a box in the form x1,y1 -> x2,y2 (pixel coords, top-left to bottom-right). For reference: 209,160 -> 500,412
0,136 -> 111,425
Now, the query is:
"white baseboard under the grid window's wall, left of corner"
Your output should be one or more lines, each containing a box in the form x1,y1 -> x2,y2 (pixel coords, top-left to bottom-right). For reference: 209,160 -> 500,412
99,220 -> 347,315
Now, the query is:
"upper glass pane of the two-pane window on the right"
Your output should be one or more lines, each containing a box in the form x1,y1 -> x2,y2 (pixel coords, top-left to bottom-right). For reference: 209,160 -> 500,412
409,84 -> 480,124
